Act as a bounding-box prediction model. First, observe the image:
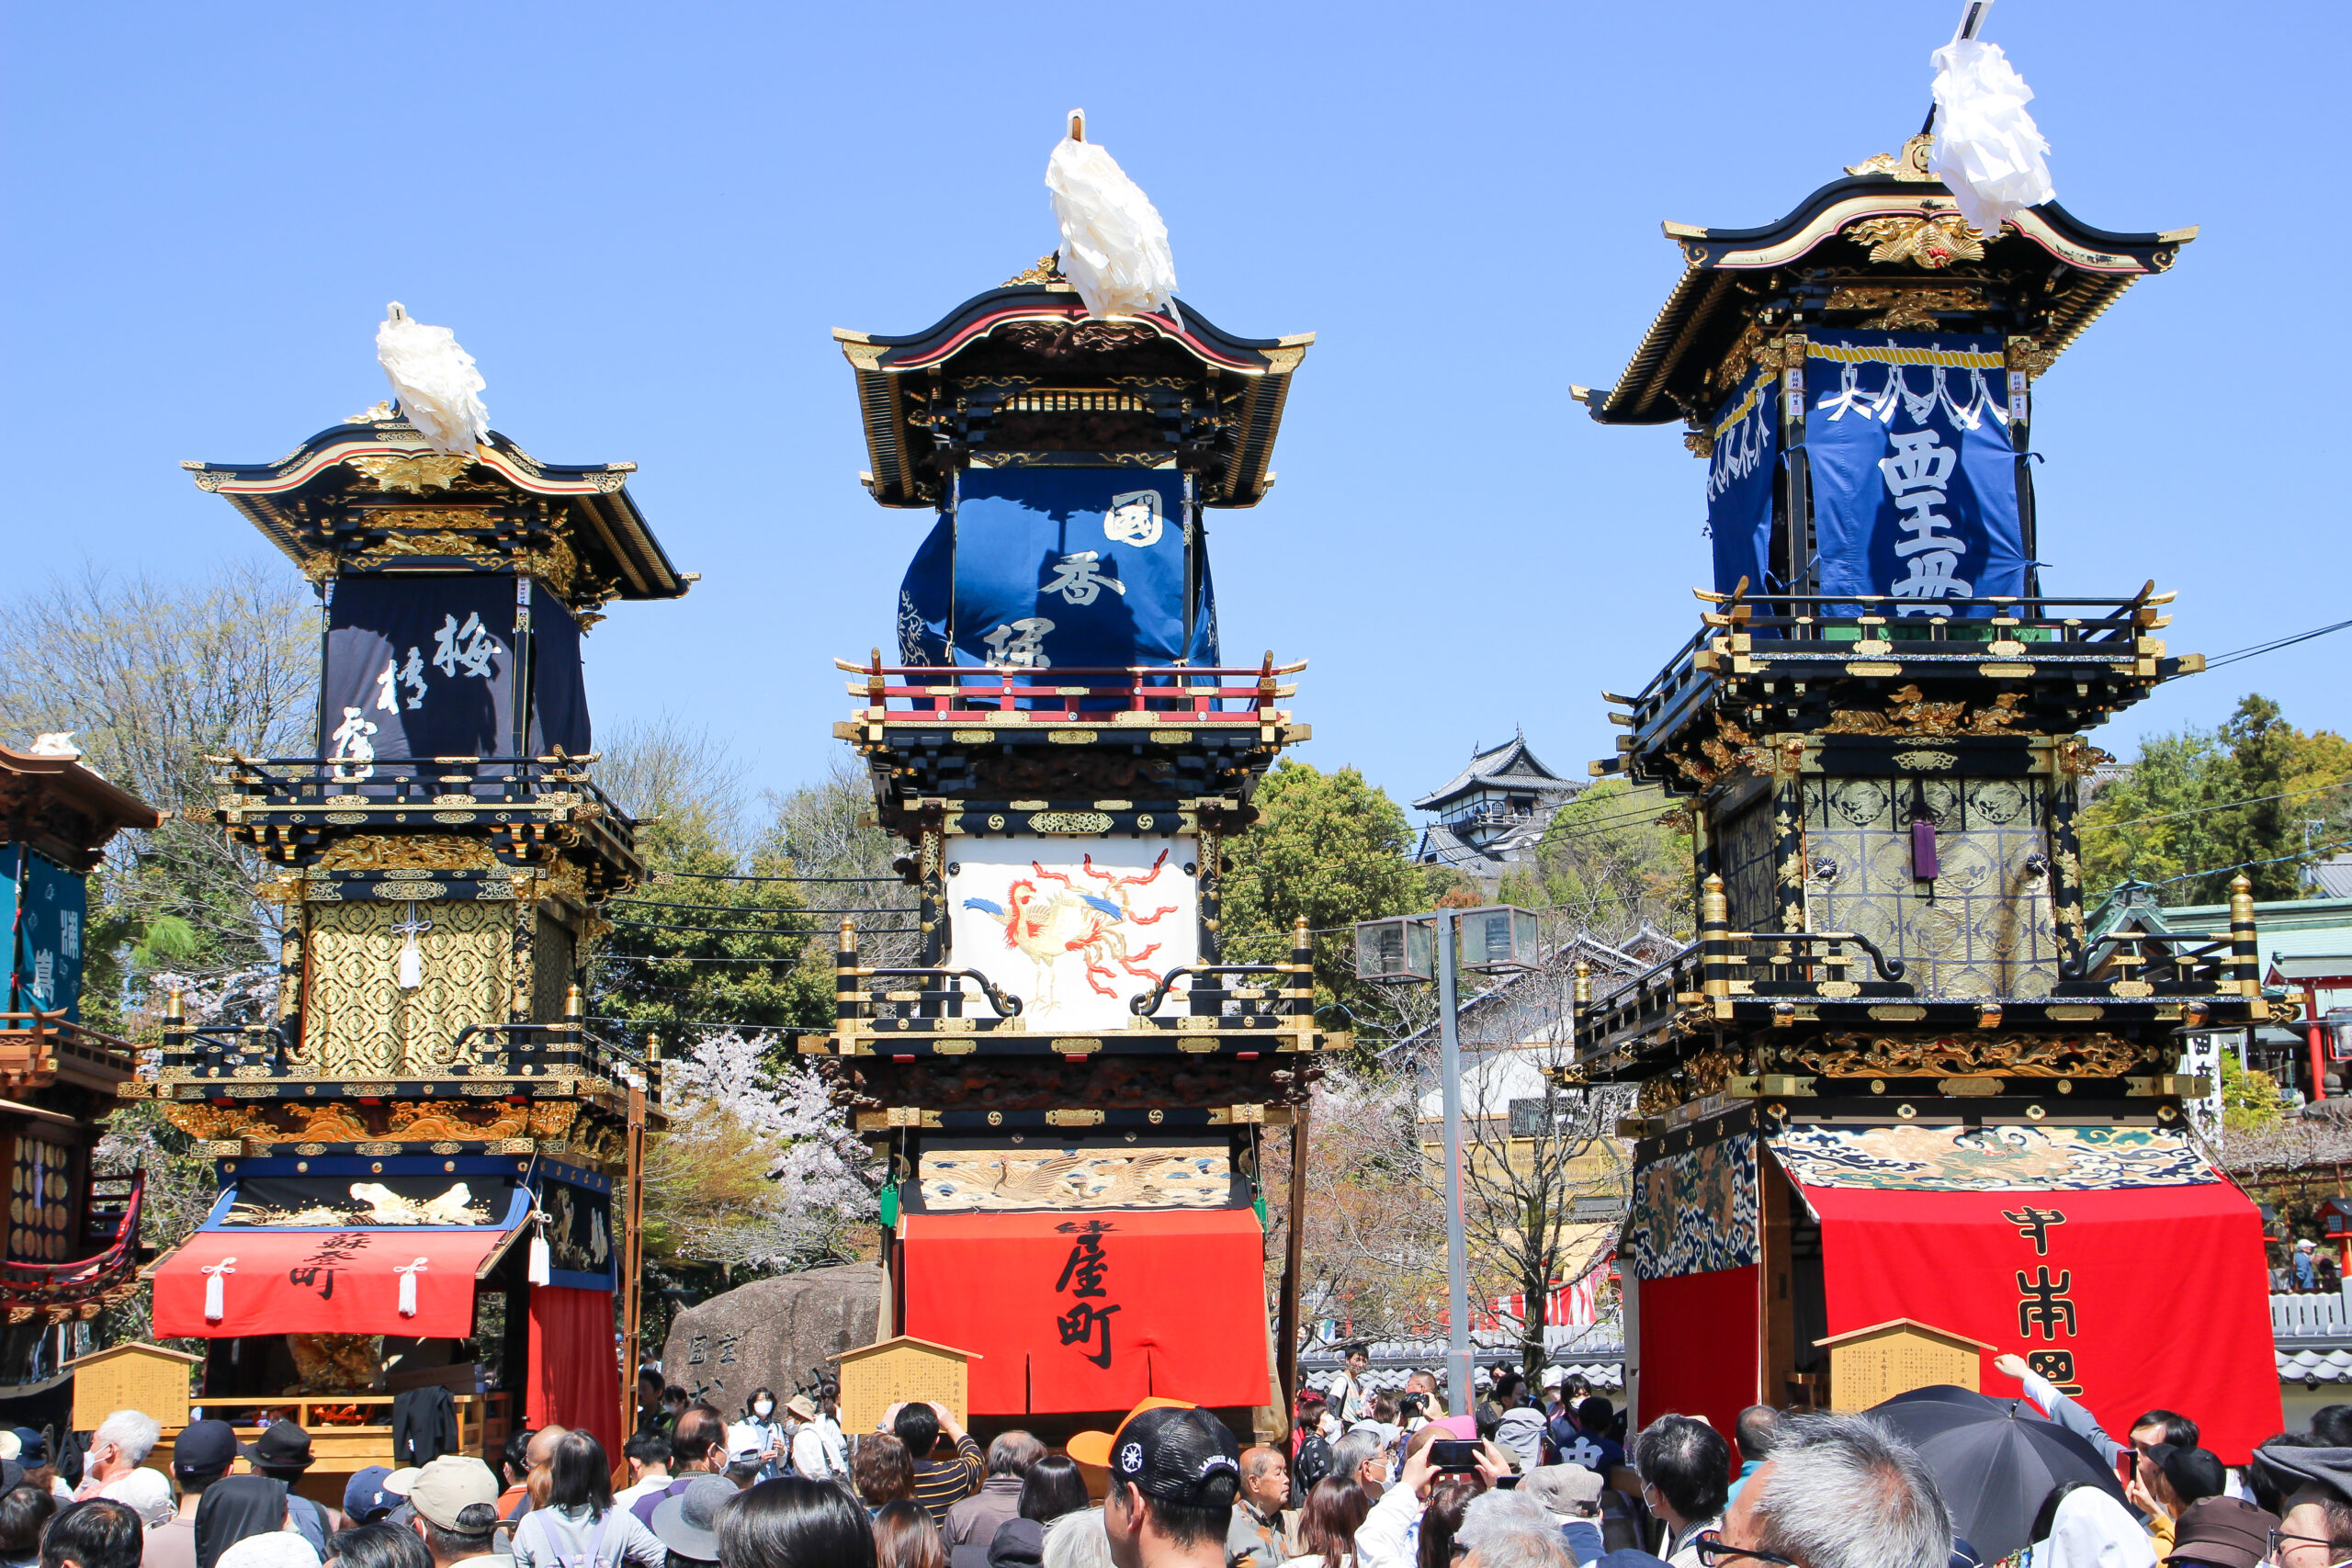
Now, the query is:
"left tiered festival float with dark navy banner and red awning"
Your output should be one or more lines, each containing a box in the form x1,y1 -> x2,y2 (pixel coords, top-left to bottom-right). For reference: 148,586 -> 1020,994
125,404 -> 692,1485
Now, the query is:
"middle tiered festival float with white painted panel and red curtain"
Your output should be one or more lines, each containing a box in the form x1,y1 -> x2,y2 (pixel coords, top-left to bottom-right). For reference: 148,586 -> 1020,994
823,259 -> 1331,1432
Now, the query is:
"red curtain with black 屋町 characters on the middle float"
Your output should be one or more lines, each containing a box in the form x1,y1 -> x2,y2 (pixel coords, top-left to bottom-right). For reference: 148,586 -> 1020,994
900,1208 -> 1268,1416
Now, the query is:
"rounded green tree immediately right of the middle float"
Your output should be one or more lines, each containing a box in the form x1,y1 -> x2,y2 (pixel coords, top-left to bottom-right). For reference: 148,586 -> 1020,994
1218,757 -> 1423,1010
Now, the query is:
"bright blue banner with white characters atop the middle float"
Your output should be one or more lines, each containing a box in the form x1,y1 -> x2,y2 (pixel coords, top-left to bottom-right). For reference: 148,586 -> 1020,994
899,468 -> 1216,670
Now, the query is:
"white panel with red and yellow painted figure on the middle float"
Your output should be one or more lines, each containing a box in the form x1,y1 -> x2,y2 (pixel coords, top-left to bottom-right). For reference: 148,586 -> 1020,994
948,835 -> 1200,1034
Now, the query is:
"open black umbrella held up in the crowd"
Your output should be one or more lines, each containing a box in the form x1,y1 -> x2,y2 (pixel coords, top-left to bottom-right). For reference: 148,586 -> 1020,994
1870,1384 -> 2124,1563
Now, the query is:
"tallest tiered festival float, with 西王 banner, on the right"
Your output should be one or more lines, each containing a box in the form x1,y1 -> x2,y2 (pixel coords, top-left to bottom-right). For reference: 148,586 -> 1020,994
1578,136 -> 2279,1462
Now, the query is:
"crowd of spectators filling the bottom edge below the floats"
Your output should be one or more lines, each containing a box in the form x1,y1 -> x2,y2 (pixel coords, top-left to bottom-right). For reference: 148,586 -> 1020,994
14,1352 -> 2352,1568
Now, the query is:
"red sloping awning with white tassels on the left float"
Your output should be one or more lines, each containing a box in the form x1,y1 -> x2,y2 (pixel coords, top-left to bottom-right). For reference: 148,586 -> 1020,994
155,1229 -> 508,1340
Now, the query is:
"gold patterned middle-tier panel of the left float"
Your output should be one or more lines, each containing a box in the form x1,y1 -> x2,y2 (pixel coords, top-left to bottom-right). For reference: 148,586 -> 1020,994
303,900 -> 515,1077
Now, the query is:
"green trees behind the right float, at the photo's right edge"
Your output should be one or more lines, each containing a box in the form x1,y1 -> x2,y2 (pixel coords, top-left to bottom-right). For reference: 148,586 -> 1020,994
2082,694 -> 2352,903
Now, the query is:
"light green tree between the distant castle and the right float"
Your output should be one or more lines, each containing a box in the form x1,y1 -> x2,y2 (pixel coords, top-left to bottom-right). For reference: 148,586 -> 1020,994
1500,778 -> 1693,942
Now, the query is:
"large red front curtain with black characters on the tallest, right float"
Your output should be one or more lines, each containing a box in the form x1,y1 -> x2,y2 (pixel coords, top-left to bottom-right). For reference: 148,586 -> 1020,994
1796,1182 -> 2284,1464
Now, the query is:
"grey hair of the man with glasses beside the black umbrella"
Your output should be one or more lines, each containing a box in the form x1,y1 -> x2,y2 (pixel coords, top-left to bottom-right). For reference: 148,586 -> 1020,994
1747,1416 -> 1952,1568
